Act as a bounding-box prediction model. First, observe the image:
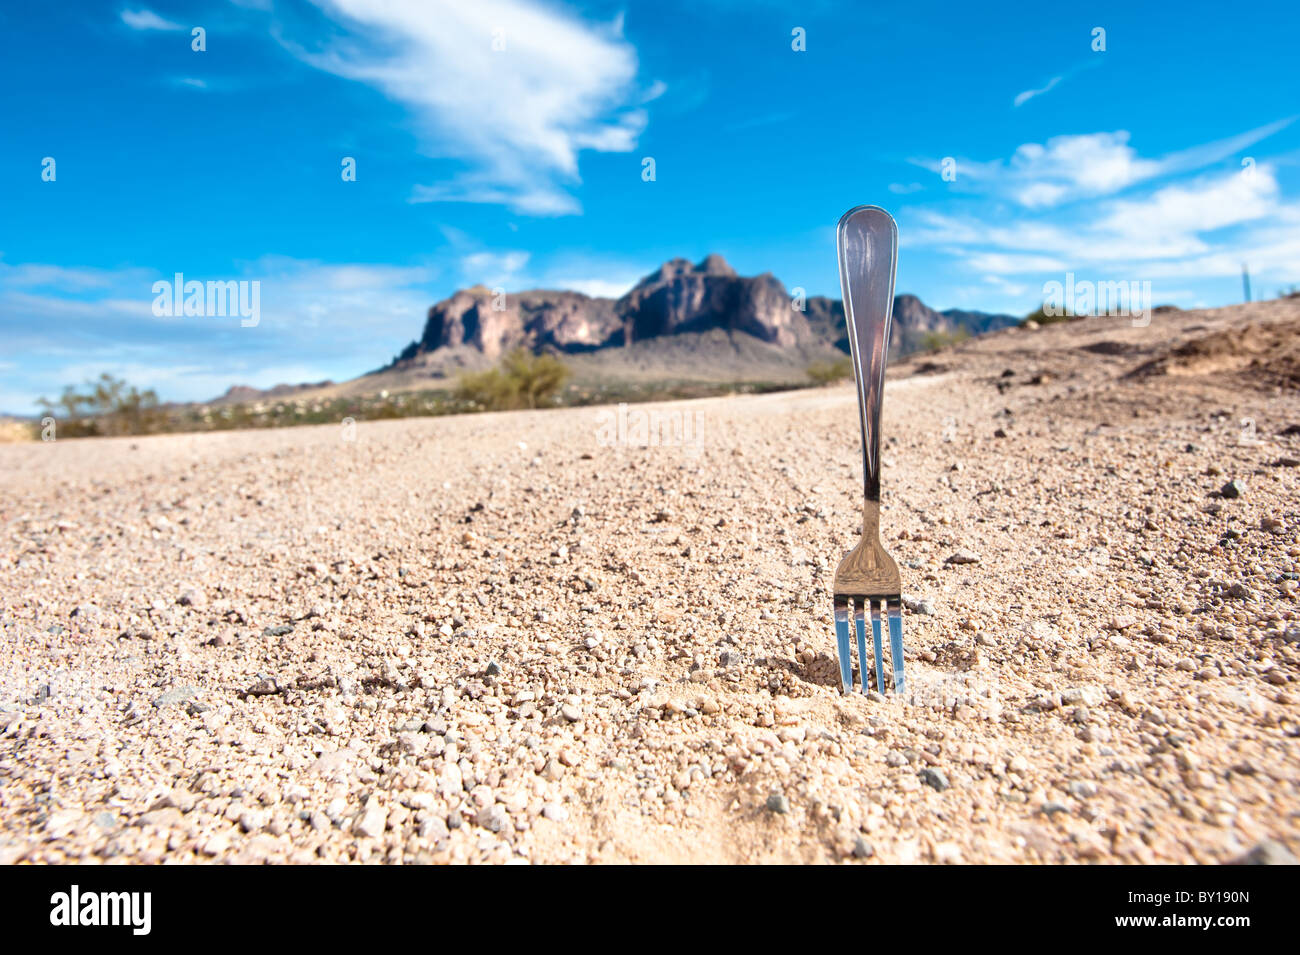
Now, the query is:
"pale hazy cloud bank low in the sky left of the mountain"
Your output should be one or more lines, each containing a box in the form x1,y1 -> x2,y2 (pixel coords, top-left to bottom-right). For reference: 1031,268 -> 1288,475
0,256 -> 437,413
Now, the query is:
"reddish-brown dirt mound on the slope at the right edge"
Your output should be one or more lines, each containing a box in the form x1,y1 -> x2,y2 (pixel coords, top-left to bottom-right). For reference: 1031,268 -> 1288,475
1128,320 -> 1300,387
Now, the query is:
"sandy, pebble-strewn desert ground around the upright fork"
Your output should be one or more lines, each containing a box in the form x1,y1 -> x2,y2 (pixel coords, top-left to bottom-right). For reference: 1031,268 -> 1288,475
0,299 -> 1300,863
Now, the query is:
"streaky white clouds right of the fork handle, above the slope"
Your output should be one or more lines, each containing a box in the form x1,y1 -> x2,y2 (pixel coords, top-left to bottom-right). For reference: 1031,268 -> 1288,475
906,118 -> 1300,314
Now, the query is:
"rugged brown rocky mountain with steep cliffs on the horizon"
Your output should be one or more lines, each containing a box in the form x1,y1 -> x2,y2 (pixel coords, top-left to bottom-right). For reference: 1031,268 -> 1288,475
389,255 -> 1018,368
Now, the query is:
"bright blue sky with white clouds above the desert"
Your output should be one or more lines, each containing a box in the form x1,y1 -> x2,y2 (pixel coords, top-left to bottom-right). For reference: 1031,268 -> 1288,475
0,0 -> 1300,413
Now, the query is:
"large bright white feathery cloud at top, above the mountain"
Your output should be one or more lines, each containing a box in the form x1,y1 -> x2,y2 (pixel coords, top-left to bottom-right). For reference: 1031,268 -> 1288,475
281,0 -> 650,216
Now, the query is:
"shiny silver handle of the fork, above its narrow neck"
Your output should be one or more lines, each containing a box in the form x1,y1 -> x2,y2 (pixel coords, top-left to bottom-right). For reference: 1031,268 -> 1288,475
836,205 -> 898,500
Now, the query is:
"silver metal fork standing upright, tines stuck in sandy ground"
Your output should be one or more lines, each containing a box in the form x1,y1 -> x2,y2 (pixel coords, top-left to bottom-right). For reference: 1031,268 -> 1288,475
835,205 -> 905,694
